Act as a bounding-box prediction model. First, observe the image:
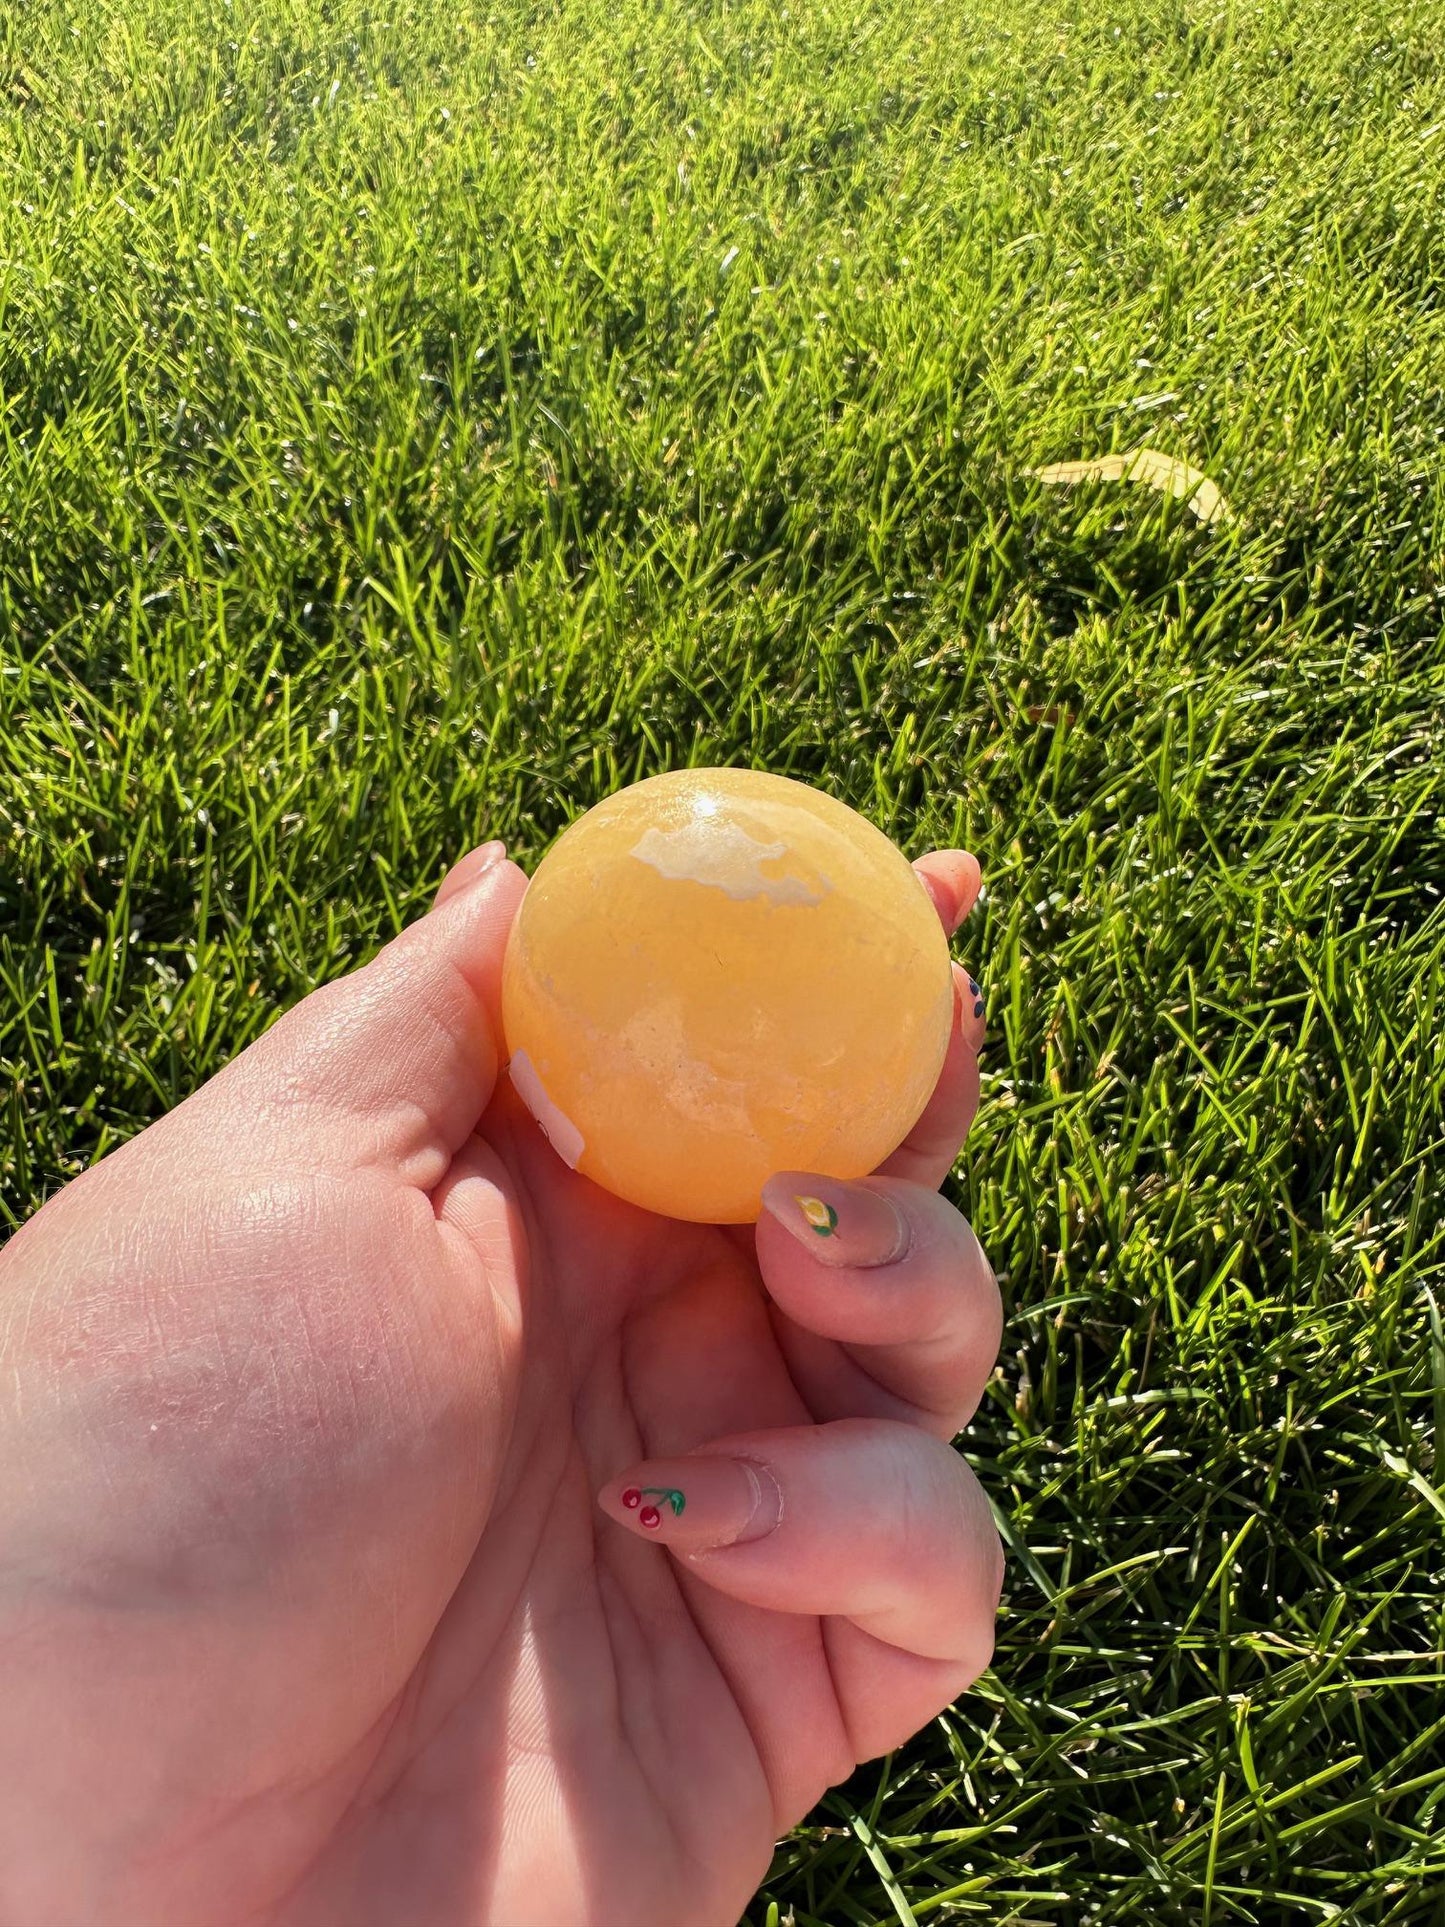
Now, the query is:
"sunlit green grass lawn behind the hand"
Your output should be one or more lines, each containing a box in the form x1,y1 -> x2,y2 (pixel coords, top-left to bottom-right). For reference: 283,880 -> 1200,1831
0,0 -> 1445,1927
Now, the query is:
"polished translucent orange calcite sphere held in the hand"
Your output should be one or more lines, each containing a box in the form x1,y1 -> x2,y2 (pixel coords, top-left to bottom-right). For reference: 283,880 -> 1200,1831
503,769 -> 954,1224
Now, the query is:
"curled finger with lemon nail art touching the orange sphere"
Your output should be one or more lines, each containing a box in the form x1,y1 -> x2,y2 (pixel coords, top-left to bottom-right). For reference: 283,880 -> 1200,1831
757,1172 -> 1004,1438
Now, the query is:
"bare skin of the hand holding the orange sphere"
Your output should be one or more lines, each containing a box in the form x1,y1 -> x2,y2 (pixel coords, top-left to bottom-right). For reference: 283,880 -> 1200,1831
0,846 -> 1002,1927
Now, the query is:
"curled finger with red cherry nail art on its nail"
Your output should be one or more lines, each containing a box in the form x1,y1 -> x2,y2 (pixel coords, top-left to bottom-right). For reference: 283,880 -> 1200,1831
597,1418 -> 1002,1678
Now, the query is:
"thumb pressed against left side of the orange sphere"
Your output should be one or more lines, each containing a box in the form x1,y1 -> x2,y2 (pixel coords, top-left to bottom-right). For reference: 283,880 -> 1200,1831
200,844 -> 526,1191
